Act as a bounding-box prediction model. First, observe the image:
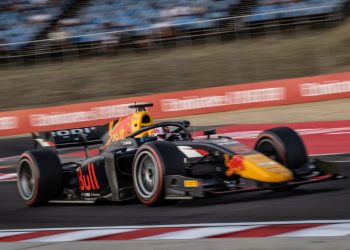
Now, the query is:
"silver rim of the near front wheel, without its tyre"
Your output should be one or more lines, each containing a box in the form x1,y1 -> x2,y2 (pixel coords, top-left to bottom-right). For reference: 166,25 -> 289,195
135,151 -> 159,199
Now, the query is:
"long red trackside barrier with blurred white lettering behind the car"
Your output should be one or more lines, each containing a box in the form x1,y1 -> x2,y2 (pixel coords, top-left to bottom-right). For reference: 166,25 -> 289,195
0,72 -> 350,136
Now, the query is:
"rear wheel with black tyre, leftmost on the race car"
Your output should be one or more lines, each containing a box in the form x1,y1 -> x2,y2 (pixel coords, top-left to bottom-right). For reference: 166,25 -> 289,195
17,149 -> 62,206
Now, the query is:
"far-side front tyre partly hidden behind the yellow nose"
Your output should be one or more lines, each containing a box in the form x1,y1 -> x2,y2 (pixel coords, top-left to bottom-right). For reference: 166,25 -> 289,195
255,127 -> 311,191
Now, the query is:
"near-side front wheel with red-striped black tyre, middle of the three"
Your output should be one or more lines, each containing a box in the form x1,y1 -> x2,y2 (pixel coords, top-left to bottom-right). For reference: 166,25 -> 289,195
132,141 -> 186,206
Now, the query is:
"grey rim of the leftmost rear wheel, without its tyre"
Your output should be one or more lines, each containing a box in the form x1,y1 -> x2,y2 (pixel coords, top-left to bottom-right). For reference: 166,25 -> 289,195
17,160 -> 35,200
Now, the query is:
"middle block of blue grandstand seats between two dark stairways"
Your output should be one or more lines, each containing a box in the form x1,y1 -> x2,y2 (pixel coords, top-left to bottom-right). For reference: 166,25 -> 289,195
63,0 -> 241,43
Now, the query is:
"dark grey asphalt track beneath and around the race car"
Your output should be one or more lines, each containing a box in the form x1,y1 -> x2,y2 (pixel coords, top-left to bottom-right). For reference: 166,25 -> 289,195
0,133 -> 350,229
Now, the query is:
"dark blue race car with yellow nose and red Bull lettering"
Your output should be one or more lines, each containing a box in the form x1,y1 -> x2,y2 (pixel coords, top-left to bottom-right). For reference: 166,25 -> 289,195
17,103 -> 345,206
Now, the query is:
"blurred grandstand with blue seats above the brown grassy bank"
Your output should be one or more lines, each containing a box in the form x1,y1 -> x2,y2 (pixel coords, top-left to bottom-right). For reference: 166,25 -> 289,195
0,0 -> 349,53
